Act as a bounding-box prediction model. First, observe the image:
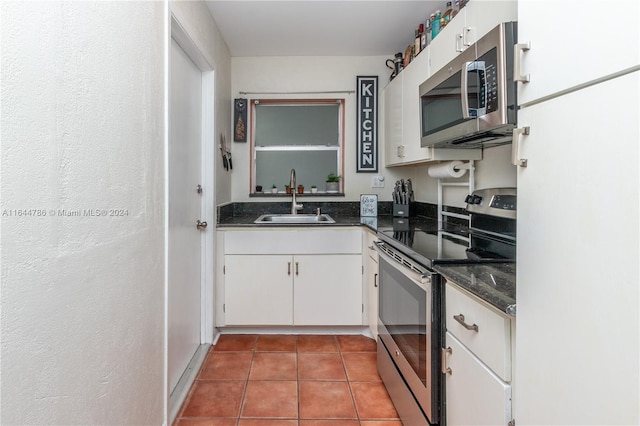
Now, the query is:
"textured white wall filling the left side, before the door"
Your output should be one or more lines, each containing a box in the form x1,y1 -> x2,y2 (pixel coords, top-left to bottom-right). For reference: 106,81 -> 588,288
0,1 -> 167,424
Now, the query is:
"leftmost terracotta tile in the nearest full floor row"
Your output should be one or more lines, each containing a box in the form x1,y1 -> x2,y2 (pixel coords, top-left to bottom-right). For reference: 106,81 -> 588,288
182,380 -> 246,418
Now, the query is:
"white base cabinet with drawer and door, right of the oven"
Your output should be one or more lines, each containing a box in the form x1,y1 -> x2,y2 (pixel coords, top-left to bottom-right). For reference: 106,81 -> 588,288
443,283 -> 512,426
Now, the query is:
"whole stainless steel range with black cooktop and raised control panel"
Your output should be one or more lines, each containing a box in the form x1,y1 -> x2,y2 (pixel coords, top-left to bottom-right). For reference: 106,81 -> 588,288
376,188 -> 516,426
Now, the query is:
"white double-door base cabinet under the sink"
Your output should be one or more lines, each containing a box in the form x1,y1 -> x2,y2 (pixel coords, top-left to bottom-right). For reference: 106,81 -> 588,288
224,229 -> 363,326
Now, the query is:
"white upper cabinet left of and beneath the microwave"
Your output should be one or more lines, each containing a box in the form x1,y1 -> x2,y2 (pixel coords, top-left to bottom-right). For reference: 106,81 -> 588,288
382,50 -> 482,167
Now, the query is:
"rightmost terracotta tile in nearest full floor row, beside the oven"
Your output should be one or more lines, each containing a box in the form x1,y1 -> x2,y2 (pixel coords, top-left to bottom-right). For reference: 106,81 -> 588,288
350,382 -> 399,420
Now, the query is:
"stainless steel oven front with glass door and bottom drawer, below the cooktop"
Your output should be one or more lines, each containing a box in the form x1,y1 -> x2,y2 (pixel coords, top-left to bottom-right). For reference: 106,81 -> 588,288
376,243 -> 442,426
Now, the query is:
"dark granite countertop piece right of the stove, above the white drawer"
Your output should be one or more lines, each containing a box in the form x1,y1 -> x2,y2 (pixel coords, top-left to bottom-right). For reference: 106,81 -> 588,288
434,263 -> 516,317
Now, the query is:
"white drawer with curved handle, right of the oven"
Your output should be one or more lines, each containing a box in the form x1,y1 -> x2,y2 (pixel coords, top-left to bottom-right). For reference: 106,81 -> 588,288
446,284 -> 511,382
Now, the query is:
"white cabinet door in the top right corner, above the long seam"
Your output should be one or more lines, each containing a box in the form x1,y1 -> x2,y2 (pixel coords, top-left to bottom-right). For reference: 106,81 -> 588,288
518,0 -> 640,104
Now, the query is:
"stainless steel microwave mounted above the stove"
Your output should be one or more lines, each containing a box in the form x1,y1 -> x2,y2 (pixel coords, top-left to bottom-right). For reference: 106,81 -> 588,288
420,22 -> 517,148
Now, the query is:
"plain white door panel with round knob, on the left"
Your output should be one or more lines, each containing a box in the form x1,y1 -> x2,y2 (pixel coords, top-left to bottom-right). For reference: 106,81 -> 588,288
168,39 -> 203,391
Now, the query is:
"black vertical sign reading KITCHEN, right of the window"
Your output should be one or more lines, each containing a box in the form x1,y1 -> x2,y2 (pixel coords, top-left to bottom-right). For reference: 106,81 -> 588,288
356,76 -> 378,173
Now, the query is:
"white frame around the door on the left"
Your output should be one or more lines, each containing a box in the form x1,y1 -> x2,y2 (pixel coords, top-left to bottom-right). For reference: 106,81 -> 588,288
164,7 -> 216,425
